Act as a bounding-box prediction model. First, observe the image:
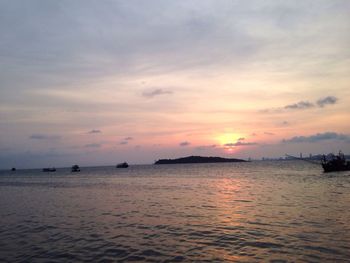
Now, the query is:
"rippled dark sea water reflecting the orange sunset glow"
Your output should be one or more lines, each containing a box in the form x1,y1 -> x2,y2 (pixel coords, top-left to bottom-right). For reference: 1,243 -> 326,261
0,161 -> 350,262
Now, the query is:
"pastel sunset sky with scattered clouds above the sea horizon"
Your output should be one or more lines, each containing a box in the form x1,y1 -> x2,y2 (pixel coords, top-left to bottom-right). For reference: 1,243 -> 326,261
0,0 -> 350,169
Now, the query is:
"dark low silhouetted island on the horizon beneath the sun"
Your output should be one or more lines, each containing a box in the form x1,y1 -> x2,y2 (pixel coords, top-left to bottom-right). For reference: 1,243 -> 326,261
154,156 -> 246,164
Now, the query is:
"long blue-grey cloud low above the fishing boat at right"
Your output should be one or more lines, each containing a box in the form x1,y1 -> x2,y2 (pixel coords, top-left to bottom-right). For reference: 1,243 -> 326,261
282,132 -> 350,143
